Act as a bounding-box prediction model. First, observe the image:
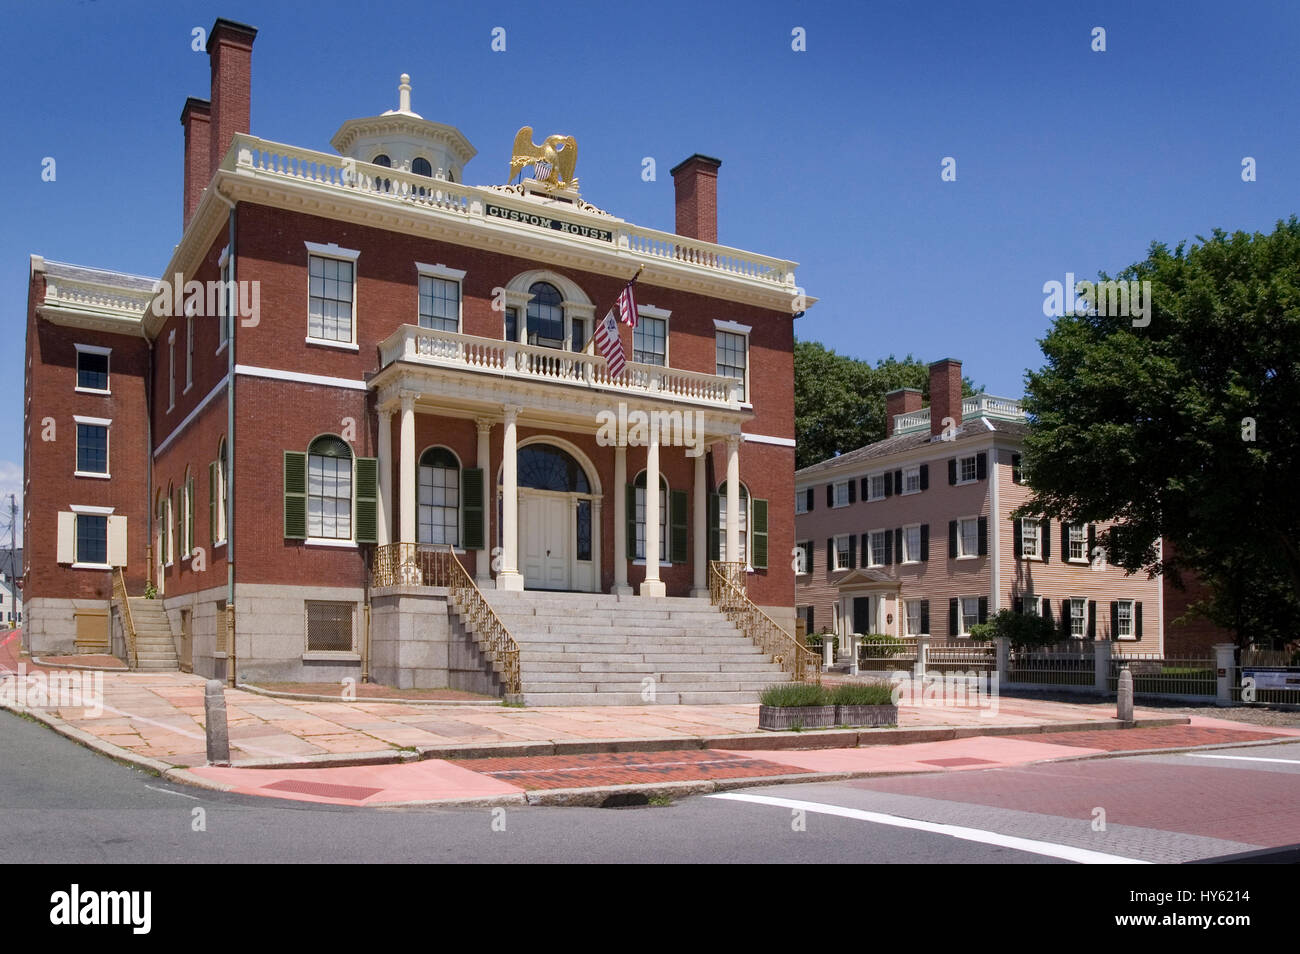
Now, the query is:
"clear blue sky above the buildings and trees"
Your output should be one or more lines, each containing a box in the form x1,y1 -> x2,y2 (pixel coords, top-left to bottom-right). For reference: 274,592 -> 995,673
0,0 -> 1300,545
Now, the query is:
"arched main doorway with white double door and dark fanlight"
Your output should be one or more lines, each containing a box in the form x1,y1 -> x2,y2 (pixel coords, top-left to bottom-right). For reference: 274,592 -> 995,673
497,439 -> 601,593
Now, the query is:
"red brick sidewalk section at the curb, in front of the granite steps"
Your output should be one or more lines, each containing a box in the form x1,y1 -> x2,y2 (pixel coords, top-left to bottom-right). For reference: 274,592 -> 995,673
455,749 -> 803,789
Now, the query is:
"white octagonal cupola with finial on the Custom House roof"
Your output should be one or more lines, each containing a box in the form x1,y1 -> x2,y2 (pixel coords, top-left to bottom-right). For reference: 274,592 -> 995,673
330,73 -> 477,182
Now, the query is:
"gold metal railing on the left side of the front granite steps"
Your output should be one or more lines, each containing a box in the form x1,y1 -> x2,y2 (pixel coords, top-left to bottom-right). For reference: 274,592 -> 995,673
371,543 -> 523,695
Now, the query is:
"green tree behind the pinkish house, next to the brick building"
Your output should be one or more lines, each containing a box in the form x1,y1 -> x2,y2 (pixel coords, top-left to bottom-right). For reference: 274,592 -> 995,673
794,341 -> 974,468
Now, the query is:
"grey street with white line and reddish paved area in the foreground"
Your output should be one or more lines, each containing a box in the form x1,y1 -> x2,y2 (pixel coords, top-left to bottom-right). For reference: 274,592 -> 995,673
0,712 -> 1300,864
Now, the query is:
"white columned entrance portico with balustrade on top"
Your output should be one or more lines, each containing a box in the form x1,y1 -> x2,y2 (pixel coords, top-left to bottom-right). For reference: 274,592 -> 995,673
371,325 -> 766,597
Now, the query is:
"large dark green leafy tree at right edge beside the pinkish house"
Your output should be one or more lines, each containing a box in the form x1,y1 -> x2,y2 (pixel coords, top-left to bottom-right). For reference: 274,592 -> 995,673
1024,217 -> 1300,645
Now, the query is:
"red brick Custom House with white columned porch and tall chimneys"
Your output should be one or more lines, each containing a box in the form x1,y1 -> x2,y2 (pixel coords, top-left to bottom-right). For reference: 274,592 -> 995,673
25,19 -> 807,685
